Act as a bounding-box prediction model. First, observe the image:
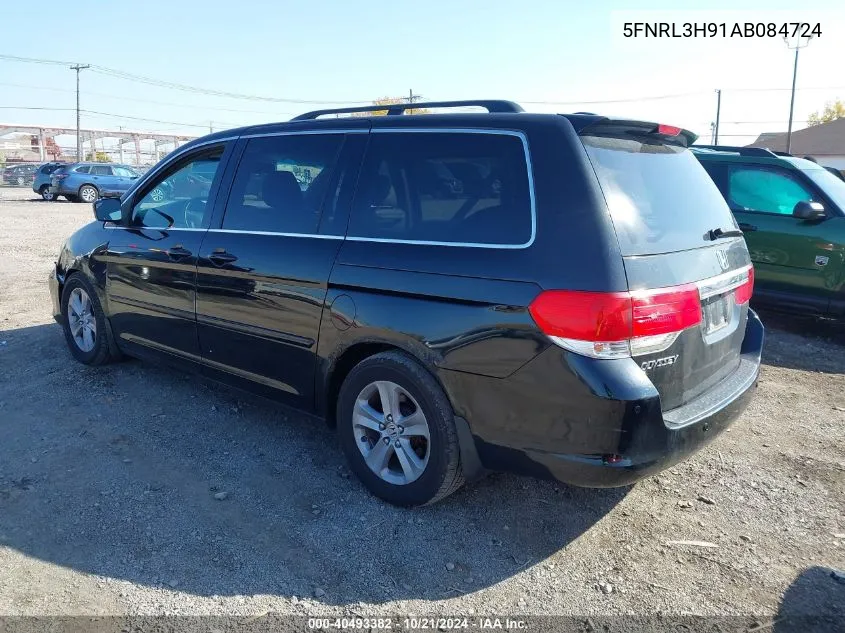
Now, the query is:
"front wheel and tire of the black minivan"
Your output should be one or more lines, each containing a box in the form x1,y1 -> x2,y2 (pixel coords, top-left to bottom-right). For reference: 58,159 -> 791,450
62,273 -> 116,365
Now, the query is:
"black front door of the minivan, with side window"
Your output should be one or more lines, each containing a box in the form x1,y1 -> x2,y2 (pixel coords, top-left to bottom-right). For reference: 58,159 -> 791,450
106,145 -> 231,362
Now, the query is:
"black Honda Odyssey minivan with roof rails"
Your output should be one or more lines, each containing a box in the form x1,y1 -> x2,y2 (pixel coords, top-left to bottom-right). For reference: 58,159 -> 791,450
50,101 -> 763,505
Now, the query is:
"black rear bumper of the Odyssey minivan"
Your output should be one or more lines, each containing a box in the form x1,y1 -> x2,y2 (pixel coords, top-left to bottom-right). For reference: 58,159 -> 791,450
447,311 -> 764,487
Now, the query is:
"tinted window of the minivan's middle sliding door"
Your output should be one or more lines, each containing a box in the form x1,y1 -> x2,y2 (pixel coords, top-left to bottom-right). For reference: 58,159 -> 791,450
223,134 -> 343,234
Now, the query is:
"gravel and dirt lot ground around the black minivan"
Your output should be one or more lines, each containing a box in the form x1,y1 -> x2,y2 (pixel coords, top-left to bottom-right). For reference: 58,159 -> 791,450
0,189 -> 845,625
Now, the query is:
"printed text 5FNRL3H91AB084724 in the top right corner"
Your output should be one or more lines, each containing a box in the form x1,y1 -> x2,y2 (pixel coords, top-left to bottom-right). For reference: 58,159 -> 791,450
622,22 -> 822,38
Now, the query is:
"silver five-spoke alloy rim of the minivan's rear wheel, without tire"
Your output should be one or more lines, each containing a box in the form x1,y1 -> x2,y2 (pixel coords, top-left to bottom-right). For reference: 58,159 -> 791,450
352,380 -> 431,485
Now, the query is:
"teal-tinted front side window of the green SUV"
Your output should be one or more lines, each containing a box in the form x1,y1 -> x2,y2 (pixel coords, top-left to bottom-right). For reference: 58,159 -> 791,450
729,165 -> 813,215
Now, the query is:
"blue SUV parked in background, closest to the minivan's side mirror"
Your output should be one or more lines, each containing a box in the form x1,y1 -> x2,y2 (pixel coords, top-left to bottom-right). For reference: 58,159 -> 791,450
49,163 -> 140,202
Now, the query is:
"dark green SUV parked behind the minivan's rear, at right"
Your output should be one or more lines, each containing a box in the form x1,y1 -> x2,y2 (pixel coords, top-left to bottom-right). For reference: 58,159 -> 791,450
692,146 -> 845,318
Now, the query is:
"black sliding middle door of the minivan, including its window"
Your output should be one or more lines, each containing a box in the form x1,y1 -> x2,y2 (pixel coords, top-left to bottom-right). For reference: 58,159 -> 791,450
197,133 -> 366,409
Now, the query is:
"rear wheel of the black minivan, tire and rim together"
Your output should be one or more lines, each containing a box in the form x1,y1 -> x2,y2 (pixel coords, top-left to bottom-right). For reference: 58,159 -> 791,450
337,352 -> 464,506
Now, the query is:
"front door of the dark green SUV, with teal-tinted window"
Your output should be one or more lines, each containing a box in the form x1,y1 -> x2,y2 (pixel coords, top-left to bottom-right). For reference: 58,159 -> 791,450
727,164 -> 843,314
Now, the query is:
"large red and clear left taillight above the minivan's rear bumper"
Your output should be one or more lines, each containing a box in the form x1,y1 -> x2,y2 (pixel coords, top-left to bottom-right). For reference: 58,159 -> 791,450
528,284 -> 701,358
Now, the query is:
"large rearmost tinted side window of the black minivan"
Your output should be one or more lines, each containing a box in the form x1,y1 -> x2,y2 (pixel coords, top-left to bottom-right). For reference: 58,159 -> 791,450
348,132 -> 533,245
